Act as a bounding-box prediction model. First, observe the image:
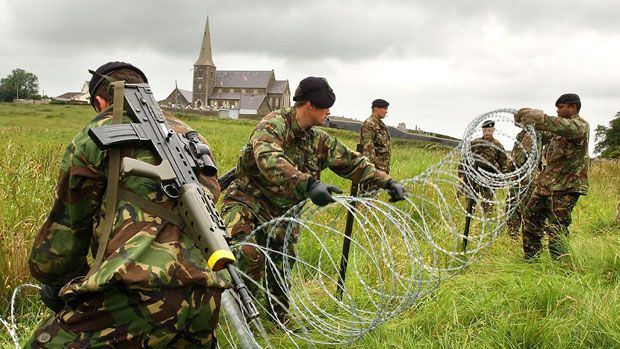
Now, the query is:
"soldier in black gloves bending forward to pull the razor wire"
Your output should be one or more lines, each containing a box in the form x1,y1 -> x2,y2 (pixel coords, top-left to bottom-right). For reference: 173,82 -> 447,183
222,77 -> 405,321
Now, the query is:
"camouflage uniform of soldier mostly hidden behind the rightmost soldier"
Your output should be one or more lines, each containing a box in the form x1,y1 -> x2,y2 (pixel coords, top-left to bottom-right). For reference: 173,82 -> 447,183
506,130 -> 540,239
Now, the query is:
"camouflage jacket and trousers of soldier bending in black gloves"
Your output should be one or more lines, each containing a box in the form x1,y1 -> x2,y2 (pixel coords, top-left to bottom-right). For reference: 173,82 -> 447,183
222,108 -> 390,316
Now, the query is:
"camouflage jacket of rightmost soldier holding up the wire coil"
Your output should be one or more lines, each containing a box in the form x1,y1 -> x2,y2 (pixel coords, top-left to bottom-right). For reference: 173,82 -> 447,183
534,114 -> 590,195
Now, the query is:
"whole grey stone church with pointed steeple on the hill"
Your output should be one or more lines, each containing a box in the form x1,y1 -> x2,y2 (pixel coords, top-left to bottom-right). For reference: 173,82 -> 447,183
159,17 -> 291,119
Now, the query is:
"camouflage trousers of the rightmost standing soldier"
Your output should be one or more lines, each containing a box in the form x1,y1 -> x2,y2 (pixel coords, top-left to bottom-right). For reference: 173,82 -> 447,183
523,193 -> 579,259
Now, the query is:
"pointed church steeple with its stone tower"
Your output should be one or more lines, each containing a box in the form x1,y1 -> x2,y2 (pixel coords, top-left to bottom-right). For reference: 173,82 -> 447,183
192,16 -> 215,107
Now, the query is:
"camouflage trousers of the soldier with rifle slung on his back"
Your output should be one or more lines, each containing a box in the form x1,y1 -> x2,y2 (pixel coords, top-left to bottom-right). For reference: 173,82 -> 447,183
25,285 -> 223,348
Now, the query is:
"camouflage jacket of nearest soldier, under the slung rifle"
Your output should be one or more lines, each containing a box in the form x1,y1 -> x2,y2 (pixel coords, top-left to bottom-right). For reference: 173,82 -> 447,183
28,113 -> 227,294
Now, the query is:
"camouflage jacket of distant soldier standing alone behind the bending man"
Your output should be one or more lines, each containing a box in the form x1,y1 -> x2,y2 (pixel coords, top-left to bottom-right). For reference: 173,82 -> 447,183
360,115 -> 392,173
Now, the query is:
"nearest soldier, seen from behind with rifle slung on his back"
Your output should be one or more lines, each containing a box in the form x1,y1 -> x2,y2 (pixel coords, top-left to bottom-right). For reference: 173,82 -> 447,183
26,62 -> 230,348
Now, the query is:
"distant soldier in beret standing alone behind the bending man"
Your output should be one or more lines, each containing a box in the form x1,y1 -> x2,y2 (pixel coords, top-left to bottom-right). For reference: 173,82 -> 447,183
360,99 -> 392,192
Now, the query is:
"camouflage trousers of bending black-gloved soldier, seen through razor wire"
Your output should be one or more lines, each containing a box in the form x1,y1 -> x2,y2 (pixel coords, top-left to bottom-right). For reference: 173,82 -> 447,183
222,202 -> 299,321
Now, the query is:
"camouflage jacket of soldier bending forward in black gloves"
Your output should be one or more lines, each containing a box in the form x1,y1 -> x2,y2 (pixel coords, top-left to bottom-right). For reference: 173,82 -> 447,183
224,108 -> 390,220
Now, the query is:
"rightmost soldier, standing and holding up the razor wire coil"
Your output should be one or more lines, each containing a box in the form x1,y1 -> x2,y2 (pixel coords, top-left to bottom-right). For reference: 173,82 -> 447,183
515,93 -> 590,260
